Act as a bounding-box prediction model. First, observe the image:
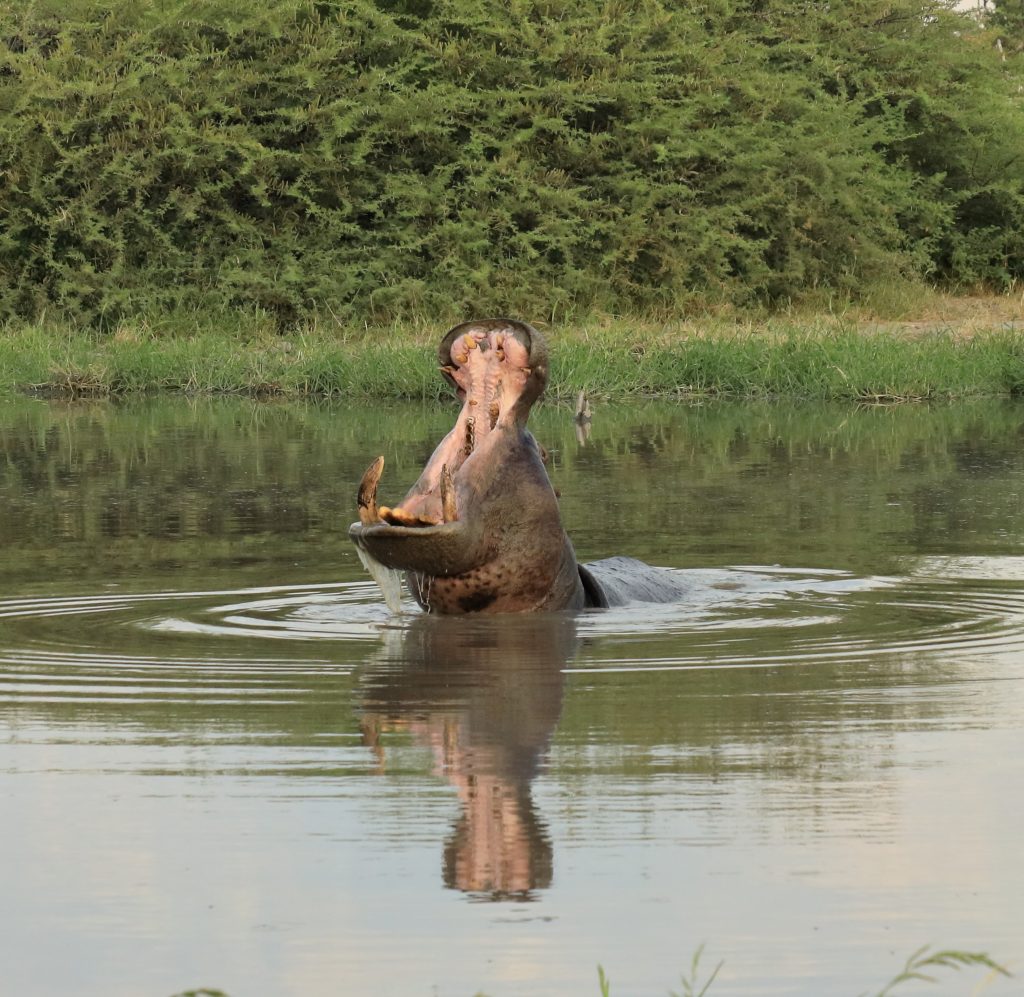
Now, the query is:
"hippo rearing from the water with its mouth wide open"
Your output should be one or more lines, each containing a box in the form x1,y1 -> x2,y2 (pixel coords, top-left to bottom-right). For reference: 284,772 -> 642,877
348,318 -> 683,614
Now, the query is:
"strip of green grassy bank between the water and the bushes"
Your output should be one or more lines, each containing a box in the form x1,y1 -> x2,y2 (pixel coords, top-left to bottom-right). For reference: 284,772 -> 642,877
6,299 -> 1024,401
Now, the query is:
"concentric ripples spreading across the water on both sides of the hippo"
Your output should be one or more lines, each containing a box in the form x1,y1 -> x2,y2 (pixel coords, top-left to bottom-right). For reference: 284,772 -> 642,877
0,558 -> 1024,706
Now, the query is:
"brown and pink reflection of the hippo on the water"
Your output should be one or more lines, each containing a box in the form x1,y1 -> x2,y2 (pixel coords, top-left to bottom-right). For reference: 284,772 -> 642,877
360,613 -> 575,900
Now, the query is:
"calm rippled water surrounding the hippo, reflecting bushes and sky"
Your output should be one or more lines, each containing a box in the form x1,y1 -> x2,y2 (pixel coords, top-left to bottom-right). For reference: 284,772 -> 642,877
0,399 -> 1024,997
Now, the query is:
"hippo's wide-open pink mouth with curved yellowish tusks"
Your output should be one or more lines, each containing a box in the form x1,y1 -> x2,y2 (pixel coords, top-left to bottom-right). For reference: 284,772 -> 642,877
356,318 -> 548,532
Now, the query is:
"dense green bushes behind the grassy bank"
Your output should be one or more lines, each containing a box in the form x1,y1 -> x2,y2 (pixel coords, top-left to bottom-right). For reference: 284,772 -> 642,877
0,0 -> 1024,321
